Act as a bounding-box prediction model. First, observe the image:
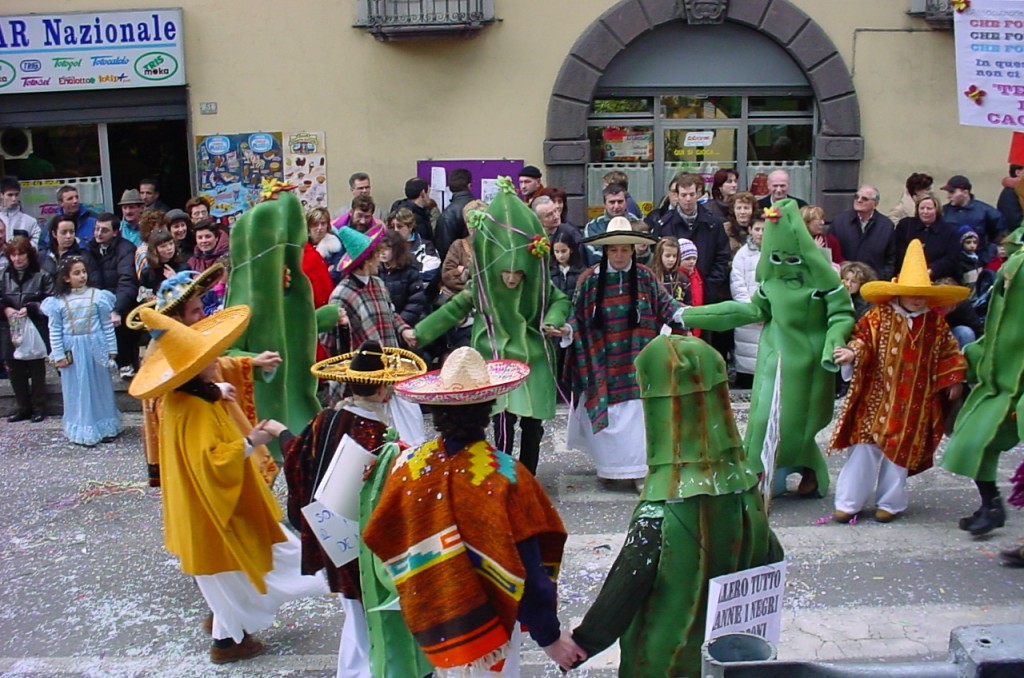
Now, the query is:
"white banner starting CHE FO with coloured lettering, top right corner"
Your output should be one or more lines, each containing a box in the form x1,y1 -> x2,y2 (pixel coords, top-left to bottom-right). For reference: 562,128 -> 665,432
952,0 -> 1024,131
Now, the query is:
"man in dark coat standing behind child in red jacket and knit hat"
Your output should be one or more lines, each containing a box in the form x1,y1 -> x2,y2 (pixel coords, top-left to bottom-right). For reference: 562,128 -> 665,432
654,172 -> 731,304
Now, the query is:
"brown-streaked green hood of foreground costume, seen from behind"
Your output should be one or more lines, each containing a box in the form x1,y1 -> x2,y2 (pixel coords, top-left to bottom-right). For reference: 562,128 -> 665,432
634,333 -> 765,501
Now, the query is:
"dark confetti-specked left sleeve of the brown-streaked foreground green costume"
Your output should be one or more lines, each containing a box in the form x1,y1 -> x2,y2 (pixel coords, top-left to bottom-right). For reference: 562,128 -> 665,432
572,517 -> 663,656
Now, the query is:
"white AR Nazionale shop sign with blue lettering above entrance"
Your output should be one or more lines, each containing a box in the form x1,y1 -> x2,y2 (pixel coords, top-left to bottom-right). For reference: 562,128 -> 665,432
0,9 -> 186,94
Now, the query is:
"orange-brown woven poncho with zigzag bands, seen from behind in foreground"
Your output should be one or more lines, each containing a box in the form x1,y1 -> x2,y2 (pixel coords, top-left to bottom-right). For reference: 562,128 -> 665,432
362,439 -> 566,669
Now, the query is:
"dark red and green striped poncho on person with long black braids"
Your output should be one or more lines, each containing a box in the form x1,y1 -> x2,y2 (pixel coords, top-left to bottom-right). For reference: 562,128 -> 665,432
567,264 -> 682,433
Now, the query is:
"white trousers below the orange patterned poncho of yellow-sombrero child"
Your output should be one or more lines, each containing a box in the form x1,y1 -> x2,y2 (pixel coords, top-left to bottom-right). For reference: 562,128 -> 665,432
836,443 -> 909,513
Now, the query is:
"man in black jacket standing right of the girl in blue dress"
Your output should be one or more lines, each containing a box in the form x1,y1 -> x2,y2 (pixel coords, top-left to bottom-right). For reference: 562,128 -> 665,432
85,212 -> 139,379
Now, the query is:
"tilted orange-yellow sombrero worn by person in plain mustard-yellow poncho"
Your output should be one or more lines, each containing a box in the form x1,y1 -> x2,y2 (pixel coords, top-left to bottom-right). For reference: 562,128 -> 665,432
128,305 -> 249,399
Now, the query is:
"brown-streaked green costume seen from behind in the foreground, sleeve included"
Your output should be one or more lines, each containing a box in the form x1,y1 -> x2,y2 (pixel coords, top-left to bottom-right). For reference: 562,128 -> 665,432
572,336 -> 783,678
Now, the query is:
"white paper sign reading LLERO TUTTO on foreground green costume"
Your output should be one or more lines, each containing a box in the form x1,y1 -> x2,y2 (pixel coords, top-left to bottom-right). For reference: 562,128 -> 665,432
705,560 -> 785,643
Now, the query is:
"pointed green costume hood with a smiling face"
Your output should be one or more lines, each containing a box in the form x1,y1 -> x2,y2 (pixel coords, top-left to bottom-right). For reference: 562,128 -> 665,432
755,198 -> 842,292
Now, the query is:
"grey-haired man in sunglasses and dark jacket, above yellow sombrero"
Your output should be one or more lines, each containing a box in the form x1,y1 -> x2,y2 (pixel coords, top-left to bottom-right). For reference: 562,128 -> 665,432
829,185 -> 896,281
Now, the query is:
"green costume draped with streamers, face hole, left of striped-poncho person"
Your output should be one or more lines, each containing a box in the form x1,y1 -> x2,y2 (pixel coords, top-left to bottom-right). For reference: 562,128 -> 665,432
416,176 -> 571,428
